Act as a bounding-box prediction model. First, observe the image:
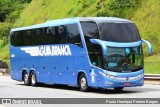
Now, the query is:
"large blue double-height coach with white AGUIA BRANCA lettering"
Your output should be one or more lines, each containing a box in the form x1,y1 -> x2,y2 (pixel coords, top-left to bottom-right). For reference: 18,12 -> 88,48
10,17 -> 152,92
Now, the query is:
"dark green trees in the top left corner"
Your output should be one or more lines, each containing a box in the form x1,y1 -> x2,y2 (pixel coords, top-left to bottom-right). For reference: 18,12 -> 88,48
0,0 -> 31,45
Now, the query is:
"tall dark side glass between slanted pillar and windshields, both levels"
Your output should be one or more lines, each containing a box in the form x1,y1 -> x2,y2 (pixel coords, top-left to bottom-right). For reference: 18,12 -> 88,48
81,22 -> 102,68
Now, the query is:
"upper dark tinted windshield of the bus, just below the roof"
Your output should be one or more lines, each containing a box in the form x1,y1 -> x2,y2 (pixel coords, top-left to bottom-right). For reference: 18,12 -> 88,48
98,23 -> 140,42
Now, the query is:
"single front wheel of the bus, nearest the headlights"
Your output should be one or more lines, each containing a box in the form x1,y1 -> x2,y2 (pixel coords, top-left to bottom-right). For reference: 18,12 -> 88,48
79,74 -> 89,92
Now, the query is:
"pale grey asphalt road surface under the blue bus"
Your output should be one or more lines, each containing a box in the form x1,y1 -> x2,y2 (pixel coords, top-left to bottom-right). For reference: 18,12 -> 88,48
0,76 -> 160,107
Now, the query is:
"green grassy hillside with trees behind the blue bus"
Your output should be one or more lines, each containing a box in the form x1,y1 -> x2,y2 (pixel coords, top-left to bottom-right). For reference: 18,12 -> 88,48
0,0 -> 160,74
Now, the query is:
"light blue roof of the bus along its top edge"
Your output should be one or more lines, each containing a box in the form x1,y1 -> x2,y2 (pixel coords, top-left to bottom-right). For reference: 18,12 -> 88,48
11,17 -> 133,32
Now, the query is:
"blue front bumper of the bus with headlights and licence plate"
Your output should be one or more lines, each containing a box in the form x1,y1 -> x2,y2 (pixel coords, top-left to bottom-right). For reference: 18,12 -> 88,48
97,71 -> 144,89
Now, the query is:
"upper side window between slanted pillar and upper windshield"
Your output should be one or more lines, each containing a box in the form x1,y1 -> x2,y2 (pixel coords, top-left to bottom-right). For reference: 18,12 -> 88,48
81,22 -> 99,42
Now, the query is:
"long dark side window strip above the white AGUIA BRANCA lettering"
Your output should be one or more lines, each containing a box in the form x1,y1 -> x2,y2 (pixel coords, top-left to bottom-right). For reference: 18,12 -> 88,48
11,24 -> 82,46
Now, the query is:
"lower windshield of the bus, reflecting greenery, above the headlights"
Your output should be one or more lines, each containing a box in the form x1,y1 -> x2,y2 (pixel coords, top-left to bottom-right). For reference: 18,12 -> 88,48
104,47 -> 143,72
